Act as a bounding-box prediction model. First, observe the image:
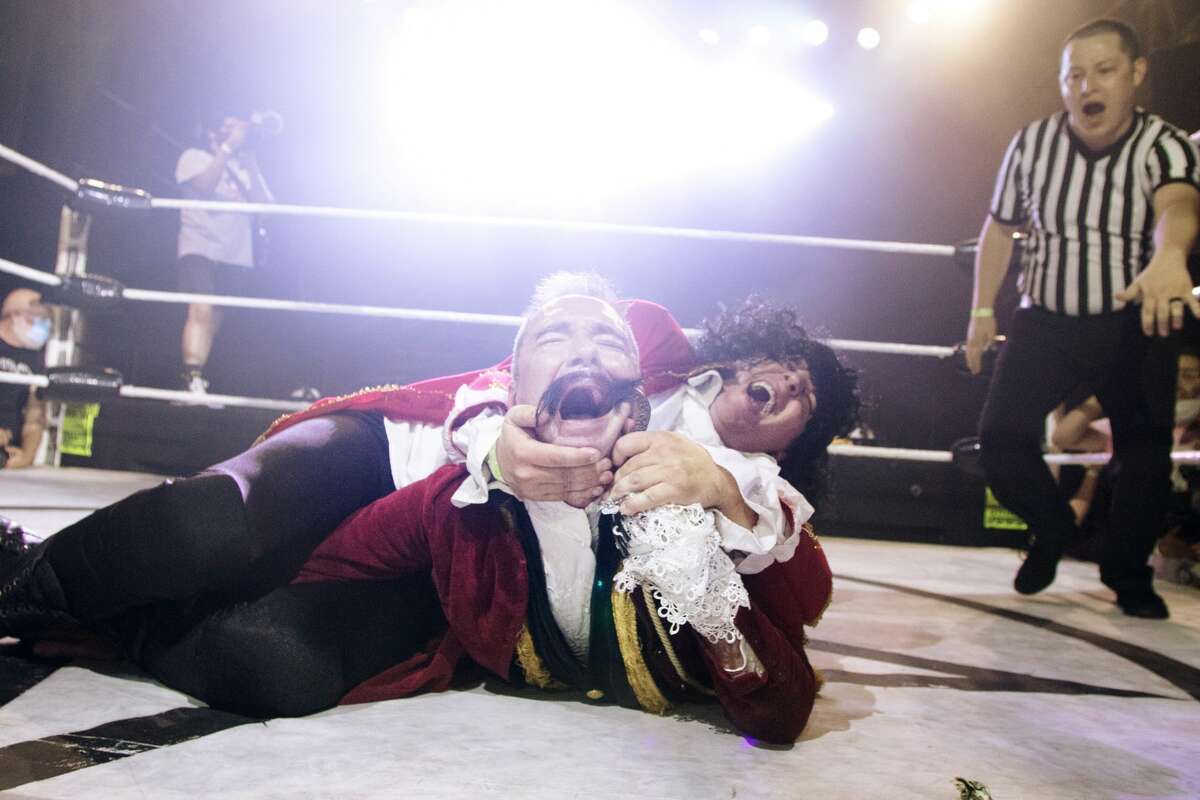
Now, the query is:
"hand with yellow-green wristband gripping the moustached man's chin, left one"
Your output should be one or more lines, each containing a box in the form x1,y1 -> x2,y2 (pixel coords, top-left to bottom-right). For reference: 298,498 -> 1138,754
496,405 -> 612,509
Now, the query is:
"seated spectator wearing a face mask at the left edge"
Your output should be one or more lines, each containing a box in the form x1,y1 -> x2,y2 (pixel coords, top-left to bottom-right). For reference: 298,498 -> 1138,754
0,289 -> 50,469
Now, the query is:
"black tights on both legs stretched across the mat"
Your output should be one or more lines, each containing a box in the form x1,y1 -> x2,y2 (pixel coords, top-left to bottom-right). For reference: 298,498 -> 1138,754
46,413 -> 440,716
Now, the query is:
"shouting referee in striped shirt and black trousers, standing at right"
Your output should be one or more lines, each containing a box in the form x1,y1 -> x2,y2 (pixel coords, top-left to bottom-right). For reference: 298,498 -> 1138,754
966,19 -> 1200,619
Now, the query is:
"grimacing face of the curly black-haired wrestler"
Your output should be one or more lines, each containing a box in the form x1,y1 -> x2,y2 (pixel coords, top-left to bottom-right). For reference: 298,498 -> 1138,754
708,360 -> 817,456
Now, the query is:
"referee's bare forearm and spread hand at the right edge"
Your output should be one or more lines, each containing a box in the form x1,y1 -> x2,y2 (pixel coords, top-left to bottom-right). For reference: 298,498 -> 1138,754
1116,184 -> 1200,336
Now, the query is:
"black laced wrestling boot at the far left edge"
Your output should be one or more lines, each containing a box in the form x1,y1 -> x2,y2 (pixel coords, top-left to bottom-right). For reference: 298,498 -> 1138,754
0,534 -> 74,638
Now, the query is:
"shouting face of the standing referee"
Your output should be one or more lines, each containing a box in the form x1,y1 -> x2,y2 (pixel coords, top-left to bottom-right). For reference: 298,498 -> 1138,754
1058,34 -> 1146,150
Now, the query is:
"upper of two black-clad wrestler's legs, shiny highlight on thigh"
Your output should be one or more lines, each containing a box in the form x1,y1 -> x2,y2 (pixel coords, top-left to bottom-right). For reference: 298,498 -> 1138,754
8,414 -> 392,632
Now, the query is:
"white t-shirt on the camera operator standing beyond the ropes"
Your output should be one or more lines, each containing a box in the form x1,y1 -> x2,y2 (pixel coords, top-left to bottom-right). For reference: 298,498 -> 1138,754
175,148 -> 254,266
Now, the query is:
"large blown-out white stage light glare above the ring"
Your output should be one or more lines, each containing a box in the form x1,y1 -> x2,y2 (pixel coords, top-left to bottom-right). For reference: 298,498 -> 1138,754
364,0 -> 832,208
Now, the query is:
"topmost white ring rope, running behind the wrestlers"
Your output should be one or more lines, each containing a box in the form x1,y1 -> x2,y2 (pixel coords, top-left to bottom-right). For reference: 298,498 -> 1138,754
0,145 -> 958,258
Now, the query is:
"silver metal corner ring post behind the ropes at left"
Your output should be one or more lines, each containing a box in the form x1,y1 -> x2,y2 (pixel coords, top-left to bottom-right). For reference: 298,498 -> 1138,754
46,205 -> 91,467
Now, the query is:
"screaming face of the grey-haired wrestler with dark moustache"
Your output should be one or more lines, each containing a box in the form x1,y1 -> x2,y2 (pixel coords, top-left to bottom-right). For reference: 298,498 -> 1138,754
510,295 -> 641,453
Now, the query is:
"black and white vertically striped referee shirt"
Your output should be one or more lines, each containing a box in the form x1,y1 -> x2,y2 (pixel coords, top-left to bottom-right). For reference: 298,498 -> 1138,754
991,109 -> 1200,317
